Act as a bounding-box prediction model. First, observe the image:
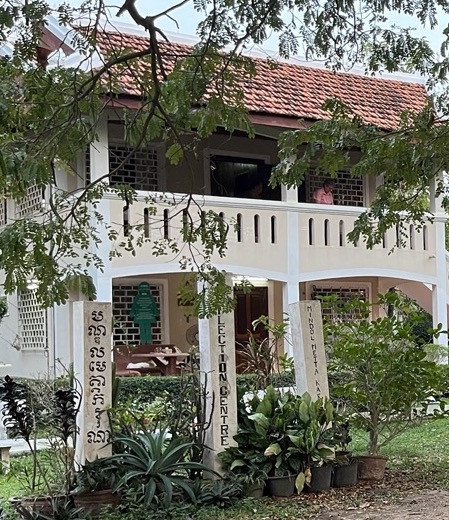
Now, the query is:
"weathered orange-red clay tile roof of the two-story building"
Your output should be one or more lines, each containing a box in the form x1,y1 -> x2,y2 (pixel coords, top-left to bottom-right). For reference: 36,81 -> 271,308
95,32 -> 427,129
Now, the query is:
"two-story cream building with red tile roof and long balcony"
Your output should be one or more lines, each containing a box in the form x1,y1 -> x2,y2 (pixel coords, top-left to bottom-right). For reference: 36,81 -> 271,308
0,22 -> 442,375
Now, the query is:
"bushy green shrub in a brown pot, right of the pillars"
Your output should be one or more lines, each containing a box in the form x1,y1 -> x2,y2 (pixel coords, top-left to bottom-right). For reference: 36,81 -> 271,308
325,292 -> 445,479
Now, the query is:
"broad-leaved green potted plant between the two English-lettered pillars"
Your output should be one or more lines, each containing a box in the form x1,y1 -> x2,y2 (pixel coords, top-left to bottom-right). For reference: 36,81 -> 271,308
222,386 -> 333,496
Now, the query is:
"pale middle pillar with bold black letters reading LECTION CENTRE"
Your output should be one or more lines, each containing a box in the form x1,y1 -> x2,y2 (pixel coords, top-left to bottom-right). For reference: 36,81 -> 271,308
198,282 -> 237,472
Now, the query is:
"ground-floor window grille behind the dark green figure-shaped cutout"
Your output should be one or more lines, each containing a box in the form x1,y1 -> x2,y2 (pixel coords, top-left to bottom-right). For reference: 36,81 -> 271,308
112,284 -> 163,345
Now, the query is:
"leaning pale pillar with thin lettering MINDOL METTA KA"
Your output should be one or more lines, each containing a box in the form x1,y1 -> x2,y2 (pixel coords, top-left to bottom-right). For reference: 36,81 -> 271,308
289,300 -> 329,400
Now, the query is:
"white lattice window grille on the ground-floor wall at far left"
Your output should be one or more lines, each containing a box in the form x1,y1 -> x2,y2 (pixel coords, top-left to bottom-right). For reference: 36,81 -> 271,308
17,289 -> 47,350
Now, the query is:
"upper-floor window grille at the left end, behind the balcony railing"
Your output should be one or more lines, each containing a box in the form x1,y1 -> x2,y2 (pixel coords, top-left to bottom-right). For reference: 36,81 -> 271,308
109,143 -> 159,191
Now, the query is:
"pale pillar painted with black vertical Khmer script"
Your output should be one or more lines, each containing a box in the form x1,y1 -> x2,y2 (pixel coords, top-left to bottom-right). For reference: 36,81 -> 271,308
73,302 -> 112,464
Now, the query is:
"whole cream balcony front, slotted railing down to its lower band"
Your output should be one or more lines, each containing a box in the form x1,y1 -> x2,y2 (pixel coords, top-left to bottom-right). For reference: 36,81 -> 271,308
108,194 -> 436,281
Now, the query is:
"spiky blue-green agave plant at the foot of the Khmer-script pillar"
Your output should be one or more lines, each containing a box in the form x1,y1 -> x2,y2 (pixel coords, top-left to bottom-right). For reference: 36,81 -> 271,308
103,431 -> 213,507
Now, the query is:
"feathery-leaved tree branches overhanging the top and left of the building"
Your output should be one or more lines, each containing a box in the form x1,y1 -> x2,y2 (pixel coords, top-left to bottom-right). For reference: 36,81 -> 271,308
0,0 -> 449,315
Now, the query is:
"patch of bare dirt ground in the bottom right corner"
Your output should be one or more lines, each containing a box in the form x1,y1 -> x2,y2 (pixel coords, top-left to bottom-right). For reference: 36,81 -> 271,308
313,490 -> 449,520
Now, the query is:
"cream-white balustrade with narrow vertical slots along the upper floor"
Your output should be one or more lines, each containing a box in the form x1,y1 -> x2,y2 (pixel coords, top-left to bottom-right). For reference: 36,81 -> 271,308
104,196 -> 435,273
